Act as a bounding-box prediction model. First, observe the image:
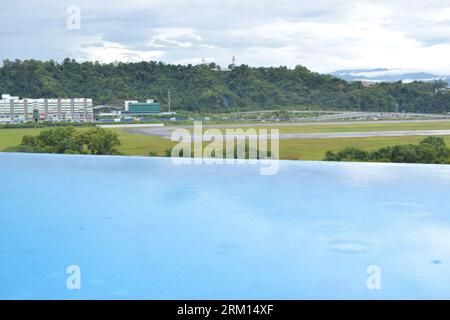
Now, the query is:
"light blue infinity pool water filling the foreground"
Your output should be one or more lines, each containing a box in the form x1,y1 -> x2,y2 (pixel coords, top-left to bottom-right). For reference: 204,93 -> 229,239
0,154 -> 450,299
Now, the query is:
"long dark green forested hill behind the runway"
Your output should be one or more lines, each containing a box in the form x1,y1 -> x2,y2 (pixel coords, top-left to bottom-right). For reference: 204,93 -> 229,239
0,59 -> 450,113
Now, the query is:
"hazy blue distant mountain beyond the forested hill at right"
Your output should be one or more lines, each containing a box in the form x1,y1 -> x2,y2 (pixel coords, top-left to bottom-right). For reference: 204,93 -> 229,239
331,68 -> 450,84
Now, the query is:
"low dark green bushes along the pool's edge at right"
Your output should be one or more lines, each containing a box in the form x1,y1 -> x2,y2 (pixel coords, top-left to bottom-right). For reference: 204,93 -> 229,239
324,137 -> 450,164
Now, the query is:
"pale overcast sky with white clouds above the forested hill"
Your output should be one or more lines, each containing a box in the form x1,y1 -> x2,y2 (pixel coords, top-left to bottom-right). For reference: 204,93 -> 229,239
0,0 -> 450,74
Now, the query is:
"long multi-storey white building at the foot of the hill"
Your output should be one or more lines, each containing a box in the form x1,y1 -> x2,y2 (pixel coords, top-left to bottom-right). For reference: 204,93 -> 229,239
0,94 -> 94,123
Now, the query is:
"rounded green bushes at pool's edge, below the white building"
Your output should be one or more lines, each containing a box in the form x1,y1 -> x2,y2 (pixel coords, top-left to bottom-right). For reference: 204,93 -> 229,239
5,127 -> 120,155
